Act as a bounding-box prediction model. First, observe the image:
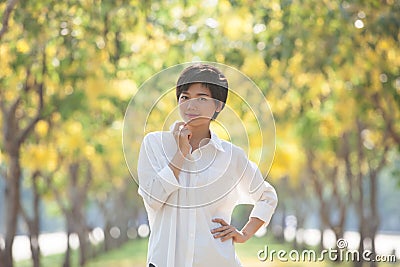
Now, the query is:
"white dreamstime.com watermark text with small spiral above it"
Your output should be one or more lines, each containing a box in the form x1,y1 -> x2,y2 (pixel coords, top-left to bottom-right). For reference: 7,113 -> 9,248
257,239 -> 397,262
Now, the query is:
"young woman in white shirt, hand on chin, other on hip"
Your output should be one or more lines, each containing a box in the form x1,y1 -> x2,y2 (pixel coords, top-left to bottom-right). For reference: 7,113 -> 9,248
138,64 -> 277,267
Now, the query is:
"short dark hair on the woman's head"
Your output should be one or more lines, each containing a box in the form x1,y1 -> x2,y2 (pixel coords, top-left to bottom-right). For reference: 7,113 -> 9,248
176,63 -> 228,118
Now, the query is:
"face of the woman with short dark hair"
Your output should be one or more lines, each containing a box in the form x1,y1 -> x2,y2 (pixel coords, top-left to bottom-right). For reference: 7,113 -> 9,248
178,83 -> 221,126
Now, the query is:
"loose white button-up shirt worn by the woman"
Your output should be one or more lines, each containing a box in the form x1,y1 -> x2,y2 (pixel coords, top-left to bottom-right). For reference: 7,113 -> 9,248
138,122 -> 277,267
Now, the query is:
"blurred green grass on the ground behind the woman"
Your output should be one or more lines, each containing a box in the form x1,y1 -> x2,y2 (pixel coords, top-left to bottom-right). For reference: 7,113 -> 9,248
15,237 -> 400,267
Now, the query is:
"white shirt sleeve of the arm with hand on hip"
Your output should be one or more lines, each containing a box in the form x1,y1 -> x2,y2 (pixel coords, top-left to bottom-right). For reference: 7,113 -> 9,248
237,151 -> 278,225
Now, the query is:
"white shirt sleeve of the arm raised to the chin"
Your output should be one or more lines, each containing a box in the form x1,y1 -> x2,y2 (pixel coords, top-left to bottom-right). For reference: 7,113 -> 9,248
138,134 -> 179,210
